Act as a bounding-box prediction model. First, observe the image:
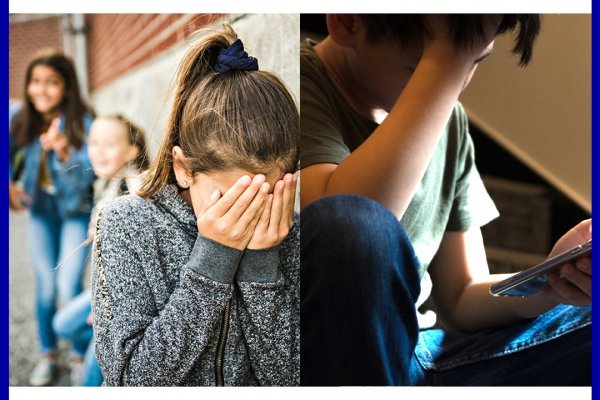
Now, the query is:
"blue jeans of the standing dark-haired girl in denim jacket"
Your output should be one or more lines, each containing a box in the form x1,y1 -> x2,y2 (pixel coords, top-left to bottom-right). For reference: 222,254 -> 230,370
28,191 -> 90,354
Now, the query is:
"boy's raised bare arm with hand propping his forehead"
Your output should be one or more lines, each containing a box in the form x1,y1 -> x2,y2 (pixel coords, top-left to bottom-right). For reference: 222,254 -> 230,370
300,19 -> 492,217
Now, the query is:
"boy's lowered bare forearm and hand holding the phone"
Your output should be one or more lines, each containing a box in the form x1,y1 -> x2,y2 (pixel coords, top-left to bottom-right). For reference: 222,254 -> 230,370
429,221 -> 591,331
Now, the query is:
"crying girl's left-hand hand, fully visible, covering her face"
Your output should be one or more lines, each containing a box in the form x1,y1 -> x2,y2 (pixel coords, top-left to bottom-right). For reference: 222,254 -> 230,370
192,175 -> 269,250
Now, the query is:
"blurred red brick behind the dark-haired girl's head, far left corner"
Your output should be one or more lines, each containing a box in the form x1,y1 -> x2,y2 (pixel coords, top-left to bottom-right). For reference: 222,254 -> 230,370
8,14 -> 63,100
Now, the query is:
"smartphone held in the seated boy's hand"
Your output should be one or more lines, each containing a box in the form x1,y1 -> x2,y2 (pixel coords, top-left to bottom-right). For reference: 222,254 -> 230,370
490,239 -> 592,297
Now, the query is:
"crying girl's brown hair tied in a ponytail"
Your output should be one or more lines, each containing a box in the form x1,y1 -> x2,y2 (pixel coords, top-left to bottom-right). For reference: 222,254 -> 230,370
140,24 -> 300,198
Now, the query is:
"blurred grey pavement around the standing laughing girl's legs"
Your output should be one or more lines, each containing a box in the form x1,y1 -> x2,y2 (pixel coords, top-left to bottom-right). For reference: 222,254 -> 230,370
8,211 -> 78,386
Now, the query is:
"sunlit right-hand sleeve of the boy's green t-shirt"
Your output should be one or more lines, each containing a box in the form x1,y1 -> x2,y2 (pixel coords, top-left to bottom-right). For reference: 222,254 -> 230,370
446,104 -> 500,232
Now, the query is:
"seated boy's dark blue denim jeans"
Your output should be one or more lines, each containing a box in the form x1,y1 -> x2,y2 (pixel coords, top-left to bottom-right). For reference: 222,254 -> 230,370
300,195 -> 591,386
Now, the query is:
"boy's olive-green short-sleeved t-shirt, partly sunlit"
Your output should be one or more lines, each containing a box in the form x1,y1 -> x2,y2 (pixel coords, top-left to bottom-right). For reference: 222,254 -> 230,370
300,41 -> 498,276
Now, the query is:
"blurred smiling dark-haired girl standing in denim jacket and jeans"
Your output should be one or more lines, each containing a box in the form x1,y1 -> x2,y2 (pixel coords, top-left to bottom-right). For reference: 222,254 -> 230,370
9,50 -> 95,386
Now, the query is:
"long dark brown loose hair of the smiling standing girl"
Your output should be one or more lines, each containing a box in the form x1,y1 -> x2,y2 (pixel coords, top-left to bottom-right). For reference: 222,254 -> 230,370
10,49 -> 93,149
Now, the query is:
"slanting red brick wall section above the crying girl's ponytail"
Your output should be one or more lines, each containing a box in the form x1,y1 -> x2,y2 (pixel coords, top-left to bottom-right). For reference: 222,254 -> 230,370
86,14 -> 221,91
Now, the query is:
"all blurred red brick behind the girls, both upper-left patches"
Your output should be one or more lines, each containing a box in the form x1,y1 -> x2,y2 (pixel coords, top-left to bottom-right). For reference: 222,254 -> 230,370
9,14 -> 227,91
